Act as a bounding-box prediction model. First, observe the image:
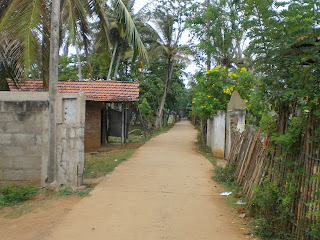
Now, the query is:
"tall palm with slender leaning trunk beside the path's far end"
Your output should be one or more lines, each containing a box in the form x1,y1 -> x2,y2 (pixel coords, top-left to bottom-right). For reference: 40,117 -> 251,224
151,9 -> 188,128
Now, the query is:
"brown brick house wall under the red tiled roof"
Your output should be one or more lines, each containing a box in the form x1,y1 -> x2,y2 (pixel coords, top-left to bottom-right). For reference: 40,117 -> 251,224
85,101 -> 105,150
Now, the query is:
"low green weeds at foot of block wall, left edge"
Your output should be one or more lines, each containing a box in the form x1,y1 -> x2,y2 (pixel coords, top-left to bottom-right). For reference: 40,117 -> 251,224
0,184 -> 38,207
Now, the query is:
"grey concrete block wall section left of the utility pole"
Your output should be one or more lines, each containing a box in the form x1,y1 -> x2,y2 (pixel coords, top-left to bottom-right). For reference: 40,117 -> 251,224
0,92 -> 49,185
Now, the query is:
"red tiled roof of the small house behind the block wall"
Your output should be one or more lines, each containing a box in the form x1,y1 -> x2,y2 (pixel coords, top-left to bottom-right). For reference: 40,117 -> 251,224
7,79 -> 139,102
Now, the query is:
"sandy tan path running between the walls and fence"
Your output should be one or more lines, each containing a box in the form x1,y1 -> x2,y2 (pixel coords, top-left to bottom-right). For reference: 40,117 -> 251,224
49,121 -> 248,240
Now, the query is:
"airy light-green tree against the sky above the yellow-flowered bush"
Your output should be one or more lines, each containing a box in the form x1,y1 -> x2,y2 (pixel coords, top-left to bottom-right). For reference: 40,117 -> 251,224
187,1 -> 244,70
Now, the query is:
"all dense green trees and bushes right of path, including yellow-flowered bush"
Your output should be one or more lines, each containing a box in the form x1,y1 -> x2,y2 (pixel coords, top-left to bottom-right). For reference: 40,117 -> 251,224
188,0 -> 320,240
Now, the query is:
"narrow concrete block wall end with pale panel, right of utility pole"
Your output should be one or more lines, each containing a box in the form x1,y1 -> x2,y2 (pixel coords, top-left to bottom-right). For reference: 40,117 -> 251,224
56,93 -> 85,186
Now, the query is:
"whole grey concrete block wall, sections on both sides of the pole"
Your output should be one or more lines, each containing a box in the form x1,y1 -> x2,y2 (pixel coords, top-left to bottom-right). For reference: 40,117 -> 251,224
0,92 -> 85,186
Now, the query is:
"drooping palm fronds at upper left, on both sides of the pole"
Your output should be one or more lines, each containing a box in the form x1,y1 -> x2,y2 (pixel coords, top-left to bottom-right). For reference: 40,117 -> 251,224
0,0 -> 147,85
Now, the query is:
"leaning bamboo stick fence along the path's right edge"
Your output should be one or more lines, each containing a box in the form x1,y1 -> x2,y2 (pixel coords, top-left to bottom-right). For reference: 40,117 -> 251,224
227,129 -> 320,240
